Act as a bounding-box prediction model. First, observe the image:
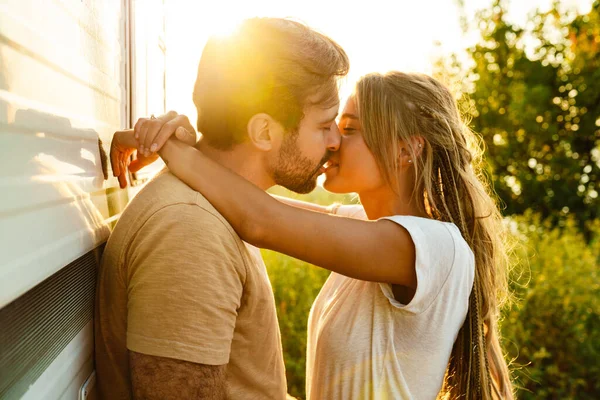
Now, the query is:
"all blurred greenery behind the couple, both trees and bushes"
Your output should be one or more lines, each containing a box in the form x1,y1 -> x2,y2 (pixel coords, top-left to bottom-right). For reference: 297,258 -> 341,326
263,0 -> 600,399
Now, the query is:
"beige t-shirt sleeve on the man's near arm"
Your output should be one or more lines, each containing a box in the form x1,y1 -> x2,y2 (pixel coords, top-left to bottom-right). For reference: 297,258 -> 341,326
126,204 -> 246,365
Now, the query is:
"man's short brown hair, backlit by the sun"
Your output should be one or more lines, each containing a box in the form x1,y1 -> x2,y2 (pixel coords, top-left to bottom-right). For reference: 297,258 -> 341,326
194,18 -> 349,149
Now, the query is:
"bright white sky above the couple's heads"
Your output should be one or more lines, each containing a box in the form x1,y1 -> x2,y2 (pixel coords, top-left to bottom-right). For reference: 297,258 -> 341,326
165,0 -> 592,123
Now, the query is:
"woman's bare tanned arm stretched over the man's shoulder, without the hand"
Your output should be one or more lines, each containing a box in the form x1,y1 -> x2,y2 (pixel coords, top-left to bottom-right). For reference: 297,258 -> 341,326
159,140 -> 417,288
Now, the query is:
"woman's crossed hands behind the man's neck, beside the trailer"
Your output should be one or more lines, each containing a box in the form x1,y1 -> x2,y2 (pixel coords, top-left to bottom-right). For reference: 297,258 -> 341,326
110,111 -> 196,189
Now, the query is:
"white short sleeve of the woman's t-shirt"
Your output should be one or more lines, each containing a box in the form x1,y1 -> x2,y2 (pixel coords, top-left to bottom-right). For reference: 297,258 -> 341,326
379,216 -> 456,314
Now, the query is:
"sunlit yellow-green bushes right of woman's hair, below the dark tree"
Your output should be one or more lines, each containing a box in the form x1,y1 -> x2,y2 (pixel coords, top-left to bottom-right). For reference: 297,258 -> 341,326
502,213 -> 600,399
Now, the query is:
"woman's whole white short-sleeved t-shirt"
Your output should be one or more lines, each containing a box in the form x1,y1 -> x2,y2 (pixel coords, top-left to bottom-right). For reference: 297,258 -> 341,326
306,206 -> 475,400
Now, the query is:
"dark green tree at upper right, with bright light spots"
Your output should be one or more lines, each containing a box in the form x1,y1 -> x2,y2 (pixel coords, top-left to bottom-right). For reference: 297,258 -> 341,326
436,0 -> 600,228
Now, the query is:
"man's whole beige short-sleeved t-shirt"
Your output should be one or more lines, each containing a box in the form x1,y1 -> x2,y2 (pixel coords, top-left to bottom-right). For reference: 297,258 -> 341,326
95,172 -> 287,400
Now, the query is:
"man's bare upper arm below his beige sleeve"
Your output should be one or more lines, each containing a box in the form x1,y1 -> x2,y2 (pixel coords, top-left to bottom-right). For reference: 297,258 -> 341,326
129,351 -> 227,400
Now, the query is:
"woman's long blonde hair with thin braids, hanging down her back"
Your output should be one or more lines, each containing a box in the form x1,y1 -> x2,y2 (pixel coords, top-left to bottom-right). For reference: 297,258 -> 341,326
355,72 -> 513,400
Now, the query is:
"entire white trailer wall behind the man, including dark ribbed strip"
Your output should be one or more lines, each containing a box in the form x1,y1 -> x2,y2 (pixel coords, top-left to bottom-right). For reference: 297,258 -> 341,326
0,0 -> 165,399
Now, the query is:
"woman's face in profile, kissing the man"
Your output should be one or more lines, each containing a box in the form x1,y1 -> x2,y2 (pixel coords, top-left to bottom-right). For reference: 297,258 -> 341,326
323,96 -> 385,193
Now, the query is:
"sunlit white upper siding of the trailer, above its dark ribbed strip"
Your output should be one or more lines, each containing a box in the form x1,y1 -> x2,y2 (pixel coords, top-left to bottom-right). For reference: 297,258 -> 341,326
0,0 -> 128,308
